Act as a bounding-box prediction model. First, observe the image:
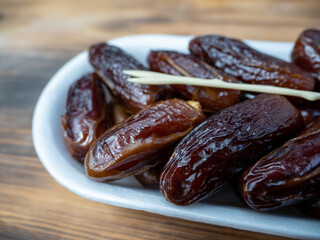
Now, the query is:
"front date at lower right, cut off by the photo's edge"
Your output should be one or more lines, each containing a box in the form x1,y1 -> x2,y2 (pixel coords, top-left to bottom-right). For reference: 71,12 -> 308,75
240,120 -> 320,210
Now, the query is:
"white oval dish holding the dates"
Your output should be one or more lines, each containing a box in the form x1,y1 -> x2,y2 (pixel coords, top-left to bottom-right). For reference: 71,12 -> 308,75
32,35 -> 320,239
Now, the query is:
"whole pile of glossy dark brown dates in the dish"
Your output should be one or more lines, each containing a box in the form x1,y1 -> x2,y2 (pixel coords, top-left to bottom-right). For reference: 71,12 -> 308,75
61,29 -> 320,217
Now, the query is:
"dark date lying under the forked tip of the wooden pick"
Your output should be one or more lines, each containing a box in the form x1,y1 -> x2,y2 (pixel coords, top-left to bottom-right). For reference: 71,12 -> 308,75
89,43 -> 162,112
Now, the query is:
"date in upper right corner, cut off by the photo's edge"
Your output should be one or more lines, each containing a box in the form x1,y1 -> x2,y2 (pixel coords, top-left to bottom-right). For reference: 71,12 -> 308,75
291,29 -> 320,81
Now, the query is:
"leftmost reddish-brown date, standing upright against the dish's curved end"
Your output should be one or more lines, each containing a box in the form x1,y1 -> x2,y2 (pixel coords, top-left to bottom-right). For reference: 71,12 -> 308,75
61,73 -> 112,162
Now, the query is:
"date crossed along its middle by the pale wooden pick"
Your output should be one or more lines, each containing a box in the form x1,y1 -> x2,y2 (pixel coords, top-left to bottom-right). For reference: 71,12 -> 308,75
148,51 -> 240,112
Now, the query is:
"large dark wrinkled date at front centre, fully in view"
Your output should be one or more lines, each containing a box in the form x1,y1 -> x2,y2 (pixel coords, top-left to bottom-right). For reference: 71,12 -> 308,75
160,94 -> 303,205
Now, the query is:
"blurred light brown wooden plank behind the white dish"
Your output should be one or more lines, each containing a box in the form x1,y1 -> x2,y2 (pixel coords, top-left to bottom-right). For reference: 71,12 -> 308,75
0,0 -> 320,50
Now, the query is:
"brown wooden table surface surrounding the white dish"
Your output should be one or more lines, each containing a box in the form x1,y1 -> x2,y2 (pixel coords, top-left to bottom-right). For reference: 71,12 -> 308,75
0,0 -> 320,239
